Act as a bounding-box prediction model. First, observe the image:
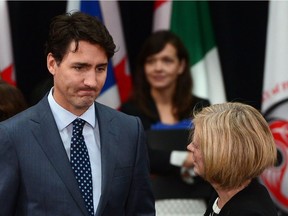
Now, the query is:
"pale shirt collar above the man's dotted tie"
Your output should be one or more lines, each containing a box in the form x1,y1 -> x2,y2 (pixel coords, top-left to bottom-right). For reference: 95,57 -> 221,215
48,87 -> 96,131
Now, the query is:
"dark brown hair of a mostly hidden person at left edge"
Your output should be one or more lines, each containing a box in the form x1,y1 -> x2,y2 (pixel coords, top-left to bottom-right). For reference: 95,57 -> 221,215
0,78 -> 28,121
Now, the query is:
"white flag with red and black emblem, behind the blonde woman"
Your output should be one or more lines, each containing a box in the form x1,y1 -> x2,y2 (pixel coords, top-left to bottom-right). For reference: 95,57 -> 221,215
260,0 -> 288,215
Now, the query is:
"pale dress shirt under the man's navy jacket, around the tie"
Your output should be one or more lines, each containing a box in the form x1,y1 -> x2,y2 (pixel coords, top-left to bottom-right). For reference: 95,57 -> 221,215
48,88 -> 101,213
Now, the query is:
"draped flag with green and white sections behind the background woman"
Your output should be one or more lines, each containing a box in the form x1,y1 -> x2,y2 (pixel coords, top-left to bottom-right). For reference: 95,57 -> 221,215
153,0 -> 226,104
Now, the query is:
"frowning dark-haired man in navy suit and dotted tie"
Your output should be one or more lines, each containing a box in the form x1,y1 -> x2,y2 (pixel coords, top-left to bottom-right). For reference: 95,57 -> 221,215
0,12 -> 155,216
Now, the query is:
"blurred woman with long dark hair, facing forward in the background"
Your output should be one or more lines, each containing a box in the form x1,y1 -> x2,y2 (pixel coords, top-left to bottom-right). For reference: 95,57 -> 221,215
121,30 -> 210,129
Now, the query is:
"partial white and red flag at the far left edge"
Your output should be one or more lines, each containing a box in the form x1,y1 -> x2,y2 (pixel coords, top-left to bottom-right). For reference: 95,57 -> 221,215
0,1 -> 16,86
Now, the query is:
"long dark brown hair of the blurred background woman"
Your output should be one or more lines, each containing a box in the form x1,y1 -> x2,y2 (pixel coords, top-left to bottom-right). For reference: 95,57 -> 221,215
133,30 -> 193,119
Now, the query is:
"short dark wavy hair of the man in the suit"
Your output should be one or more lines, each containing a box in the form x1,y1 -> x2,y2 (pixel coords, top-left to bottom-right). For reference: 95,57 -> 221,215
45,12 -> 116,64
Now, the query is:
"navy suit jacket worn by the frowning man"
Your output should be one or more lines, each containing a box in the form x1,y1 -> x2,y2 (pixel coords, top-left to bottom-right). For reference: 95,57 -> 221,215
0,96 -> 155,216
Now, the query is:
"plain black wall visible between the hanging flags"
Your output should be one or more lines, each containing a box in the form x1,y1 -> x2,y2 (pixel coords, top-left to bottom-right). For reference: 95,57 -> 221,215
8,1 -> 268,108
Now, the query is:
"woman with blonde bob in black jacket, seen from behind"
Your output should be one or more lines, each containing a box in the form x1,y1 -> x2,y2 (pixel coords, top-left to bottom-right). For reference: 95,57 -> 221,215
187,103 -> 277,216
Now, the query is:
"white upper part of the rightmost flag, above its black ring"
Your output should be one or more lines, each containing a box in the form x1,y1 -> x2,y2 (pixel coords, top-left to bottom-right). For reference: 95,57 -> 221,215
262,1 -> 288,115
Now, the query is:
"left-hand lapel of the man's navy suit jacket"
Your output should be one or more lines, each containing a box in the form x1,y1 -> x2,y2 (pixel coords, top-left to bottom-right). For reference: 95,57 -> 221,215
31,97 -> 87,215
